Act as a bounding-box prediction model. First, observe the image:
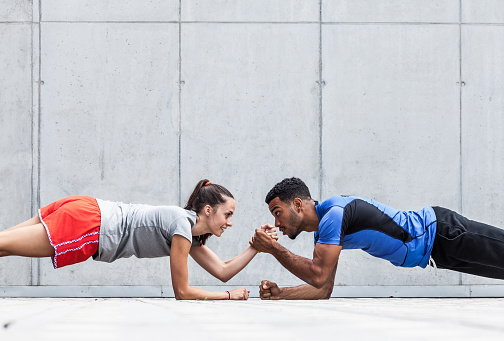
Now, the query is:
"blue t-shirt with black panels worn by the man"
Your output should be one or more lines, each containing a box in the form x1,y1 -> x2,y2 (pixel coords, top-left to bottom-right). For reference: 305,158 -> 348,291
315,196 -> 436,268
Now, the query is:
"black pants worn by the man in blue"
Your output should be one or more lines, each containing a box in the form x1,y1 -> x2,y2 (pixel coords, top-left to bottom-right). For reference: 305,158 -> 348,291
431,207 -> 504,279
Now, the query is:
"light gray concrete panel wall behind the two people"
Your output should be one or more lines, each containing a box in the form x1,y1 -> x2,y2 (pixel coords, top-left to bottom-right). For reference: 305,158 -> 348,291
0,0 -> 504,296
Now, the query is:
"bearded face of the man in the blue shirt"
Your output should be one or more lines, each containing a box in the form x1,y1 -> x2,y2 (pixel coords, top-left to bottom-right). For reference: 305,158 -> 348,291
269,197 -> 303,239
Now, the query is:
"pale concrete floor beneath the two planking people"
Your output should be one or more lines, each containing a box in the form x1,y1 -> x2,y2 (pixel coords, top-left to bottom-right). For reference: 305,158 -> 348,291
0,298 -> 504,341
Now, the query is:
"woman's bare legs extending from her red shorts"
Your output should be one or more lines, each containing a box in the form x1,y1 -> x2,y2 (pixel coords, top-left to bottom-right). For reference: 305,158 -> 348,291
0,223 -> 54,257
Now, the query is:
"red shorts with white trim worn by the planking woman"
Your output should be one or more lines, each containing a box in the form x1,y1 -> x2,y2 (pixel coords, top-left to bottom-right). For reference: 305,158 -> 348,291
39,196 -> 101,269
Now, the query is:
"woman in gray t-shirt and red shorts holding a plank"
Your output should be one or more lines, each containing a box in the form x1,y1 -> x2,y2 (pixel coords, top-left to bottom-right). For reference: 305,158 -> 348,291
0,179 -> 278,300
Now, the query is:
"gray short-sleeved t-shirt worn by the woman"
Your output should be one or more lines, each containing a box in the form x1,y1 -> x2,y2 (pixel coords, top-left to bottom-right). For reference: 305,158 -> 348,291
93,199 -> 199,263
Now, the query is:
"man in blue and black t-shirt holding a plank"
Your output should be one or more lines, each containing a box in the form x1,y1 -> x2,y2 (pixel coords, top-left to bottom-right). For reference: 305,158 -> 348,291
250,178 -> 504,299
